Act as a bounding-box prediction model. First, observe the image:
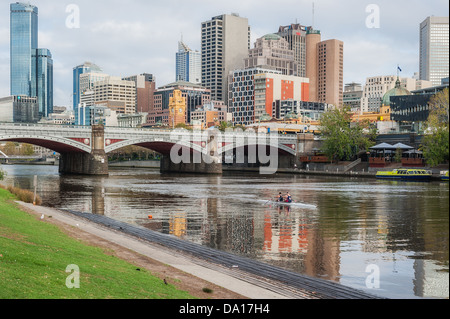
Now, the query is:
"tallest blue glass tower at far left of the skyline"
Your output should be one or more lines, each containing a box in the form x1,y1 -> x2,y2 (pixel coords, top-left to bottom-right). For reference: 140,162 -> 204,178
10,2 -> 38,96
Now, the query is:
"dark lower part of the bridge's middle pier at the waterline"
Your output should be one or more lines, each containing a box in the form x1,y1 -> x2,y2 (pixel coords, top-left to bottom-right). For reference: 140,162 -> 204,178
160,156 -> 222,174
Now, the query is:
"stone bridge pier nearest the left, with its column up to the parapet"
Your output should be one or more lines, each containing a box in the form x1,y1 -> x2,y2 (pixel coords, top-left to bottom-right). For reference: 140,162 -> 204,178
59,125 -> 109,175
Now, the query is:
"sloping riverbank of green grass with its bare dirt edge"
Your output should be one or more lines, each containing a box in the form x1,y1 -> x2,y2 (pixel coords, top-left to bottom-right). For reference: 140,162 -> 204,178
0,189 -> 248,299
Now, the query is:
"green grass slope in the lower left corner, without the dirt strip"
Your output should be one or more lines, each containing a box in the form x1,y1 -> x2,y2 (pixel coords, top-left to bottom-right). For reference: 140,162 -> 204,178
0,189 -> 197,299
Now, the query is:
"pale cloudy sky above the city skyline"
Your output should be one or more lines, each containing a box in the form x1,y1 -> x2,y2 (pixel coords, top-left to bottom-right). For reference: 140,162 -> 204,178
0,0 -> 449,107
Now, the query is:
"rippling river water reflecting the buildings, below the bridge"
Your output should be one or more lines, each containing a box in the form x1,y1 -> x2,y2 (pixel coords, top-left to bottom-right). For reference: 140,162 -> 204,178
2,165 -> 449,299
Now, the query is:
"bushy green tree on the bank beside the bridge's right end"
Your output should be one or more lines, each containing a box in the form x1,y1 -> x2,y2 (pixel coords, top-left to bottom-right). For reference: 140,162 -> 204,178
320,106 -> 374,162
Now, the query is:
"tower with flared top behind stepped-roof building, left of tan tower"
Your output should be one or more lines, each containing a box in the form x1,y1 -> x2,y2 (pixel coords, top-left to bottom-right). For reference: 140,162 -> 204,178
277,23 -> 311,77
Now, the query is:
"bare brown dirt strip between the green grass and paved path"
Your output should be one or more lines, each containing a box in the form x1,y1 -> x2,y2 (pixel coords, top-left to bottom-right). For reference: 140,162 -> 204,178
21,207 -> 246,299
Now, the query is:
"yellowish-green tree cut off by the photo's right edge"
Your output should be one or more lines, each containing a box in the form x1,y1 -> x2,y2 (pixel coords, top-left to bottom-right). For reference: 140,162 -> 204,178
422,88 -> 449,166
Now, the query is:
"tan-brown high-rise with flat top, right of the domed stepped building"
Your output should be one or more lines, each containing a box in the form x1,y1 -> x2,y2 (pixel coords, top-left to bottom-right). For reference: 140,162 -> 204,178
306,28 -> 344,106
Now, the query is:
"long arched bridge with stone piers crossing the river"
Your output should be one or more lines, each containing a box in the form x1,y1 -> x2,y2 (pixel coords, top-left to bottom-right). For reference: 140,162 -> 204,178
0,123 -> 312,175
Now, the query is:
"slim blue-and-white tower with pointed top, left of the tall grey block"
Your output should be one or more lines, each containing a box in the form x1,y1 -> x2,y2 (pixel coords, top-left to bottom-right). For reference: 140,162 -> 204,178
175,41 -> 202,84
